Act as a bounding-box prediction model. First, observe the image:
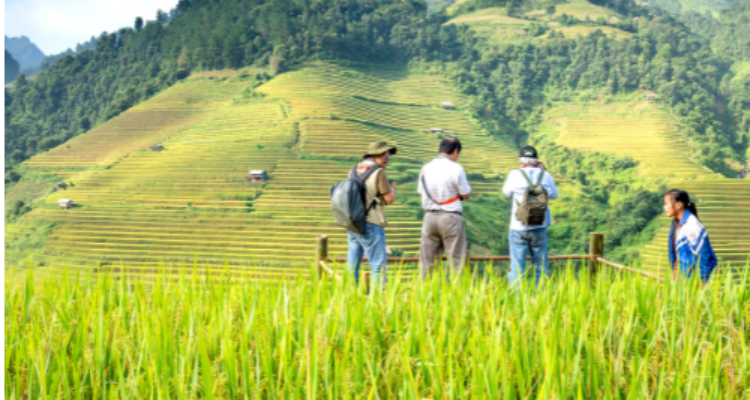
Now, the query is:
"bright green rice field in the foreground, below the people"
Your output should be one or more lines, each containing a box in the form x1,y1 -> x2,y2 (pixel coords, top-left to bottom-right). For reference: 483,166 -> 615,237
4,265 -> 750,399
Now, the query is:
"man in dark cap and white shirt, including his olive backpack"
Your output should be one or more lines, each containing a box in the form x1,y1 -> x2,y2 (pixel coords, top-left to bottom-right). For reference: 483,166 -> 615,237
503,146 -> 558,285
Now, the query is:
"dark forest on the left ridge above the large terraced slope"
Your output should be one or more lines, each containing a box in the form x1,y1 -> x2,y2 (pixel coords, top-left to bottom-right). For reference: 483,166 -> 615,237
5,0 -> 456,167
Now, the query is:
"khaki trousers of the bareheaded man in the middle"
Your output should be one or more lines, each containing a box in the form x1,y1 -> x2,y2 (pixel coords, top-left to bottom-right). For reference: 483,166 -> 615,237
419,212 -> 467,281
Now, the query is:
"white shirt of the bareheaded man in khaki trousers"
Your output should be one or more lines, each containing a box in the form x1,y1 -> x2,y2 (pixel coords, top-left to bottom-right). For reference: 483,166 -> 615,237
417,154 -> 471,212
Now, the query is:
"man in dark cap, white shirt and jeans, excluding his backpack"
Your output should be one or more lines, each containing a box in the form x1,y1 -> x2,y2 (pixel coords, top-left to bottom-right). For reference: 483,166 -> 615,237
503,146 -> 558,285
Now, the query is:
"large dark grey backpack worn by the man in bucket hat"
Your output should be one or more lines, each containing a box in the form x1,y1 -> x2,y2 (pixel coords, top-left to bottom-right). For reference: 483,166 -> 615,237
330,164 -> 380,235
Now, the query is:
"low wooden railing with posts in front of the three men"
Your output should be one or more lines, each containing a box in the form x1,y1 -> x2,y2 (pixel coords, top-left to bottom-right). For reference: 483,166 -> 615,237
315,233 -> 664,282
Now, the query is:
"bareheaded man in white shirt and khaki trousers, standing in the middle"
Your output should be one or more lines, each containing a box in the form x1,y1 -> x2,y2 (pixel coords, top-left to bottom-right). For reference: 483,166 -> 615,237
417,137 -> 471,280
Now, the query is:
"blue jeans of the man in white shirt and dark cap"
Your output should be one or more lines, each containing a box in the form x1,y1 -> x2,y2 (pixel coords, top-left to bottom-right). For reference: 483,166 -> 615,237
508,228 -> 549,285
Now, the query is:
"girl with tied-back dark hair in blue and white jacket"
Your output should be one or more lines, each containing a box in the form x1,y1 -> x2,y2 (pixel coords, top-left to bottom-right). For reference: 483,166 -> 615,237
664,189 -> 718,283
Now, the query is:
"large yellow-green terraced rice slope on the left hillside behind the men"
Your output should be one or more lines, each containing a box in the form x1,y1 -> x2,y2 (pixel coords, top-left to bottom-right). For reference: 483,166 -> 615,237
6,64 -> 516,281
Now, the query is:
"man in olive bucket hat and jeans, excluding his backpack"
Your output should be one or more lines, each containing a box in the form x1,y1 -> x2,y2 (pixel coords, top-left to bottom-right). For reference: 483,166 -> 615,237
347,141 -> 396,289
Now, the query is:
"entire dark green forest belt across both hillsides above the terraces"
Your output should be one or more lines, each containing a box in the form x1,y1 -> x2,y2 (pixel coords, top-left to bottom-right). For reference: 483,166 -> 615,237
6,0 -> 747,169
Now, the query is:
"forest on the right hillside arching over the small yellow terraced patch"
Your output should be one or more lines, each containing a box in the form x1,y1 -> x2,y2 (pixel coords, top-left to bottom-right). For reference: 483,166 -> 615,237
457,13 -> 748,170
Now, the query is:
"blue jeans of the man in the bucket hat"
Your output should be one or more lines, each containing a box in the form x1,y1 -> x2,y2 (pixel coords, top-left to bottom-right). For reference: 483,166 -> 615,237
347,222 -> 388,289
